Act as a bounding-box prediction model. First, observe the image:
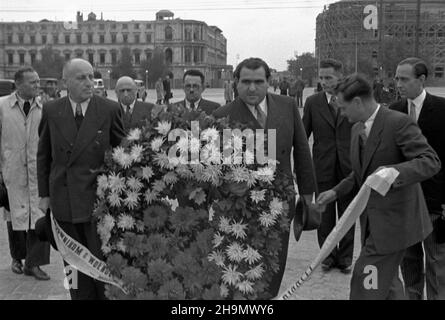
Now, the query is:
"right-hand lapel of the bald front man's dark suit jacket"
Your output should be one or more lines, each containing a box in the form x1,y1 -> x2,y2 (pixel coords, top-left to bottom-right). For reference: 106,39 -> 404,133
68,96 -> 105,165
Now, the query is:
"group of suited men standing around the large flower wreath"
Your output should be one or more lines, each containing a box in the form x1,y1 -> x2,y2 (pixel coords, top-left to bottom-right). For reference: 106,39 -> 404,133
0,58 -> 445,299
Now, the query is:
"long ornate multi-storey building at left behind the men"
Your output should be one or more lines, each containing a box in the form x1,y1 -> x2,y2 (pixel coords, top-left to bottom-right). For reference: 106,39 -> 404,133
0,10 -> 232,87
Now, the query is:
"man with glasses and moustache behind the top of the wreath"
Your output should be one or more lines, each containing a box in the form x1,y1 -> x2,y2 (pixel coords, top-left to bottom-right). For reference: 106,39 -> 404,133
169,69 -> 220,115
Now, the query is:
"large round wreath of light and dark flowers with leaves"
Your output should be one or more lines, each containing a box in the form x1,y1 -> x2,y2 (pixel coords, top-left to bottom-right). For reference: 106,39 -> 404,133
94,109 -> 295,299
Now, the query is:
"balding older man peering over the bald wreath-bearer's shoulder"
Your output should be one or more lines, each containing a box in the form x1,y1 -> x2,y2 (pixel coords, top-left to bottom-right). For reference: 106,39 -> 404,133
115,76 -> 154,132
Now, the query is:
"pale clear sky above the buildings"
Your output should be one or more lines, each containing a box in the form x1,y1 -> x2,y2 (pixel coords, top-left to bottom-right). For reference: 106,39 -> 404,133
0,0 -> 336,71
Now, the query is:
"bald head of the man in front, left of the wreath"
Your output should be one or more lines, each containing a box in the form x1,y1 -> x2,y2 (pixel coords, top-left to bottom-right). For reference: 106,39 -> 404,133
63,58 -> 94,103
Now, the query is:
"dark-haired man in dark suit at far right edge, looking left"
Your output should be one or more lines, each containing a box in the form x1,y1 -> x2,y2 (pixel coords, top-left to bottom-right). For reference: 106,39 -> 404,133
389,58 -> 445,300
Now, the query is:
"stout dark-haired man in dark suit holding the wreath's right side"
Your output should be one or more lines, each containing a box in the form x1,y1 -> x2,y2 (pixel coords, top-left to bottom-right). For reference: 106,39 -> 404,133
214,58 -> 316,298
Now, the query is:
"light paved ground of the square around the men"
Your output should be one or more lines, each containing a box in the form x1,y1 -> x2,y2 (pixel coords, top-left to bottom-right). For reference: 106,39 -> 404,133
0,88 -> 445,300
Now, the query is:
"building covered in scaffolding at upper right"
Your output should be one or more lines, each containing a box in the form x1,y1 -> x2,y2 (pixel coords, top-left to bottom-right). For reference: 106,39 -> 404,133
316,0 -> 445,85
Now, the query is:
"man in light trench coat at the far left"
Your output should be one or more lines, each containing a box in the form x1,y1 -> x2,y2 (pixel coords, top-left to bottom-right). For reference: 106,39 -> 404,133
0,67 -> 50,280
